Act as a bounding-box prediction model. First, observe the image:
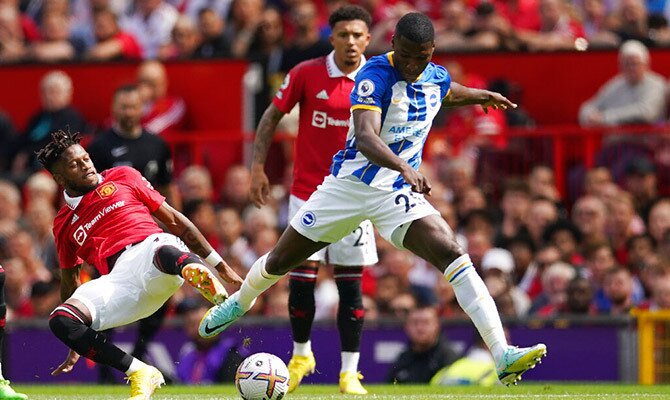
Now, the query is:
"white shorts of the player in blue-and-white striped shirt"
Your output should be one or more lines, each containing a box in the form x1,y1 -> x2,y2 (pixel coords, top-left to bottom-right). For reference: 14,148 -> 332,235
291,175 -> 439,249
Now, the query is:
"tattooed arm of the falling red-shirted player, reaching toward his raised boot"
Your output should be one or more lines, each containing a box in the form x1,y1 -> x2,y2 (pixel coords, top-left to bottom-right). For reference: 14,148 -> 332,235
153,202 -> 242,285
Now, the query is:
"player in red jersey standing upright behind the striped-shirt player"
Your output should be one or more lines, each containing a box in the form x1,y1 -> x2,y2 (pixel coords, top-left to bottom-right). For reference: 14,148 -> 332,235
251,6 -> 377,394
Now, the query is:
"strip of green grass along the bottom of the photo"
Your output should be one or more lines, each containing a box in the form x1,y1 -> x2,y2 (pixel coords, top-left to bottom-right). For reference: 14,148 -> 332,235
15,383 -> 670,400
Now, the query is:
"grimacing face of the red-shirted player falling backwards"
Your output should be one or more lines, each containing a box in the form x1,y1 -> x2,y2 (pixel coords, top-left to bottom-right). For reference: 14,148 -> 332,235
53,144 -> 100,196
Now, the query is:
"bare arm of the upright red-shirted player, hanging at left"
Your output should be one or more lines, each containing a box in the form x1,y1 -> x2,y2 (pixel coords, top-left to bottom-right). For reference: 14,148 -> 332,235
250,104 -> 284,208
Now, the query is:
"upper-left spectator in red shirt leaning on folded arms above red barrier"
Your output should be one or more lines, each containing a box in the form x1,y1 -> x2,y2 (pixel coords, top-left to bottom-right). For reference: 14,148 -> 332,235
85,8 -> 142,61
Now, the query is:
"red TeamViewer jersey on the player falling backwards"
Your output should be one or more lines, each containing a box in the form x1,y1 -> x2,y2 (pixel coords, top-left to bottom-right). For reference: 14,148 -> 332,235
54,167 -> 165,275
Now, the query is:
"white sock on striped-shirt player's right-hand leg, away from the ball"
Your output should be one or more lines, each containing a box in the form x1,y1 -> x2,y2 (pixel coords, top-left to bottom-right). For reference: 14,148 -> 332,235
444,254 -> 507,362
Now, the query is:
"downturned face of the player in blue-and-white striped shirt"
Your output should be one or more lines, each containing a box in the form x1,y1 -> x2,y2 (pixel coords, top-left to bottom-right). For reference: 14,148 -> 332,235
393,36 -> 435,82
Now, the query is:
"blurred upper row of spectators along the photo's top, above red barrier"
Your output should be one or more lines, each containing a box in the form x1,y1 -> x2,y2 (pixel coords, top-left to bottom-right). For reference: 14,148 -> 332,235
0,0 -> 670,65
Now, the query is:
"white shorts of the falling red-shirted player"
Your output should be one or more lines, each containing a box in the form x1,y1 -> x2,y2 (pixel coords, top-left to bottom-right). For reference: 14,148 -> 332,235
72,233 -> 189,331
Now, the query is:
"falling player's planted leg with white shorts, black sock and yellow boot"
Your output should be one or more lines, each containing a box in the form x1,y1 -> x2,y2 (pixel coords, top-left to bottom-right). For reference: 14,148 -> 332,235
49,234 -> 184,400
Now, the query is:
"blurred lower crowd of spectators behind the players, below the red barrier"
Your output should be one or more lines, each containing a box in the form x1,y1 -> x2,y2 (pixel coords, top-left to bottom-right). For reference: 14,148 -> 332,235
0,112 -> 670,321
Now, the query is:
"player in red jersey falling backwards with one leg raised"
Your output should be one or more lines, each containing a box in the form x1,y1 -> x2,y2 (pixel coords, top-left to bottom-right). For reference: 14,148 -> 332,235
37,131 -> 241,400
